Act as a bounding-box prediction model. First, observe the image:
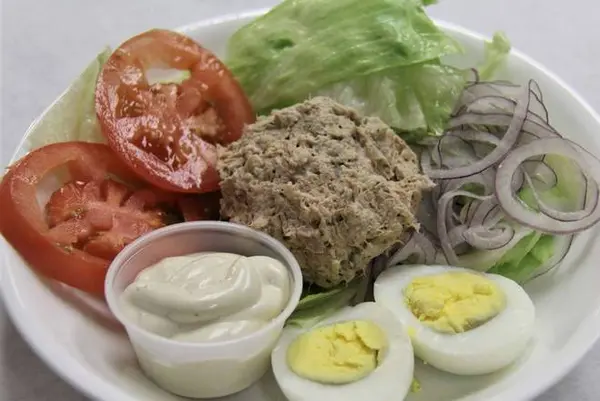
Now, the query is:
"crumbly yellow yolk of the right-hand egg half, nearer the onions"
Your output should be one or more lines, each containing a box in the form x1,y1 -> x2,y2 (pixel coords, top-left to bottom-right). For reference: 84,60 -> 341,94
404,272 -> 506,334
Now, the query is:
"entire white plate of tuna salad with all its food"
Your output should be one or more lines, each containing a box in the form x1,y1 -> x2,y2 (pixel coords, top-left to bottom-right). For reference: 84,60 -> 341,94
0,0 -> 600,401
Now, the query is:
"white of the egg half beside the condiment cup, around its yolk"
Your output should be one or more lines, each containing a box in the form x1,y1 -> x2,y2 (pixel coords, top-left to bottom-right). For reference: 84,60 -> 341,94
271,302 -> 414,401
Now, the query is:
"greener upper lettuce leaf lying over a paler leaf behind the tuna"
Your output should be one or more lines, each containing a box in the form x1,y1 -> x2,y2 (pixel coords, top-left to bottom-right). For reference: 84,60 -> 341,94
227,0 -> 460,114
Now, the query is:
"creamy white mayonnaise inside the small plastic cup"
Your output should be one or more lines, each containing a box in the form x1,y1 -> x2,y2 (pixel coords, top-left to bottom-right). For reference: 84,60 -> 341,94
121,252 -> 290,342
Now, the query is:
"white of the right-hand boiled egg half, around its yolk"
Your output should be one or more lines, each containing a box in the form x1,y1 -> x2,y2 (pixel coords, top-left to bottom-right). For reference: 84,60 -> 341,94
374,265 -> 535,375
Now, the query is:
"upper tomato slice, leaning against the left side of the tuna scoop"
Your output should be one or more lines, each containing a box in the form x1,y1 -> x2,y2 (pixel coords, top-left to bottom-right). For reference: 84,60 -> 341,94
96,29 -> 255,192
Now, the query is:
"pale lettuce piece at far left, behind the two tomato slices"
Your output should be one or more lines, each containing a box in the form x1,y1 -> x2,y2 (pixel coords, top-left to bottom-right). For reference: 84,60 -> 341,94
28,48 -> 112,149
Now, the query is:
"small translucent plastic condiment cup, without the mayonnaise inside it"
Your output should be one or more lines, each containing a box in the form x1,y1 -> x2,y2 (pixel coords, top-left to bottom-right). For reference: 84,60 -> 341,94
105,221 -> 302,398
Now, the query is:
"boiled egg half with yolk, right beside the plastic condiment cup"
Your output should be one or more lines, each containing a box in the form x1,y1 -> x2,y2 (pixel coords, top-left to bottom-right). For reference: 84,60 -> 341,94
271,302 -> 414,401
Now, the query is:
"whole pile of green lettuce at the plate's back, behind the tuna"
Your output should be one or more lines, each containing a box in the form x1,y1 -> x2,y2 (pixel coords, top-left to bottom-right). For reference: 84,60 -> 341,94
227,0 -> 510,141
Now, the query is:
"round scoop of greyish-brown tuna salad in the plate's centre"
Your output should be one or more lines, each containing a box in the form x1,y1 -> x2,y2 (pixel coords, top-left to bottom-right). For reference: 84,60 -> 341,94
217,97 -> 432,288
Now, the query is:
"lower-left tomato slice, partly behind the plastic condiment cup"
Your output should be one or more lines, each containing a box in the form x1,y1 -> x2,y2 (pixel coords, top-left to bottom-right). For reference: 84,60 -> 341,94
0,142 -> 215,295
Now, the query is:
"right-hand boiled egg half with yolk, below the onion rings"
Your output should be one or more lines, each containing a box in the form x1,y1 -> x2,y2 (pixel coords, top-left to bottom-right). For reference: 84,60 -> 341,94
374,265 -> 535,375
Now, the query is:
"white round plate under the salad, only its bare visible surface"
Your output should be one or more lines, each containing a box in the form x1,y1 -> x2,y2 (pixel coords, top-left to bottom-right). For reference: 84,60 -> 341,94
0,7 -> 600,401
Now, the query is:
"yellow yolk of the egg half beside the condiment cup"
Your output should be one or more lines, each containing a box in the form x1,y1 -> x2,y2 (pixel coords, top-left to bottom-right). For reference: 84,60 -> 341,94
287,320 -> 387,384
